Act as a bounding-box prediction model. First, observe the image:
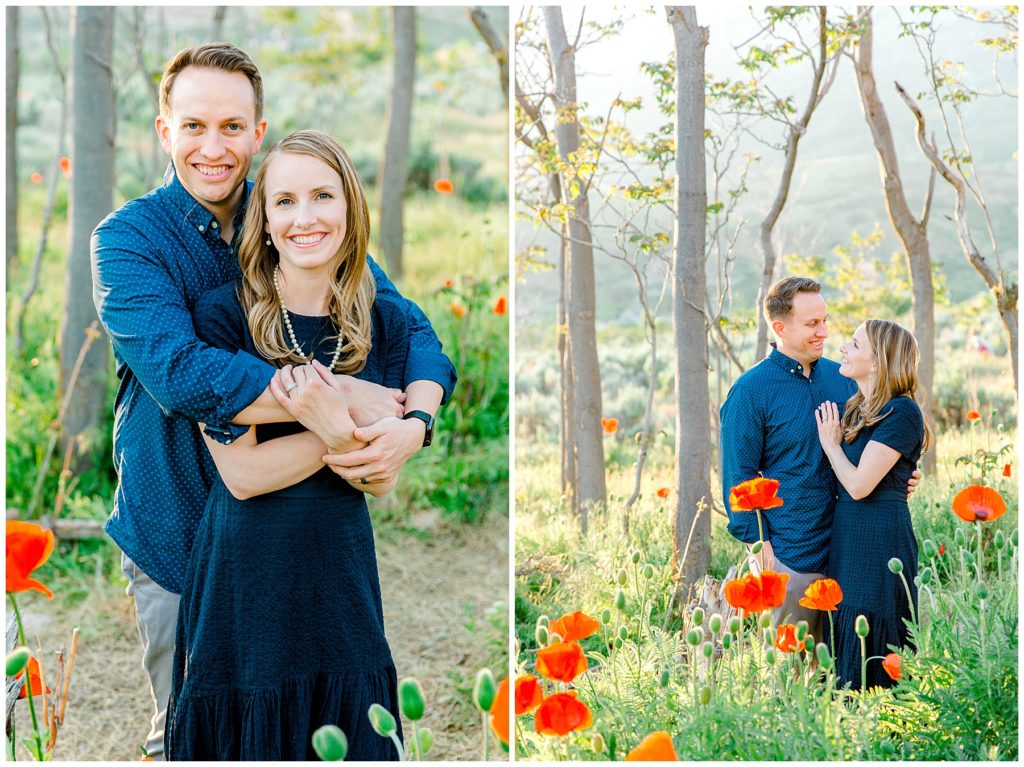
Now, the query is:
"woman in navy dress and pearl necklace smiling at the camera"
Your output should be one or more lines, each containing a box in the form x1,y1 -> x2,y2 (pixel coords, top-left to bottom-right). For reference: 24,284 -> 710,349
166,131 -> 409,761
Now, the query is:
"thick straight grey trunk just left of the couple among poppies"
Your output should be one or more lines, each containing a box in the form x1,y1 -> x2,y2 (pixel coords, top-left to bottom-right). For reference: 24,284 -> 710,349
667,6 -> 711,594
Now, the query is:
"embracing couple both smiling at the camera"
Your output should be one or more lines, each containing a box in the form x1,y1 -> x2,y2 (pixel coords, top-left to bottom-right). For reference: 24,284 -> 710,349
92,43 -> 456,760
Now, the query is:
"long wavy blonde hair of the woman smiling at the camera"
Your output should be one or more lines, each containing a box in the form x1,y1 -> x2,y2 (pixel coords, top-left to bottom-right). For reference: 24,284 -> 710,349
239,130 -> 377,374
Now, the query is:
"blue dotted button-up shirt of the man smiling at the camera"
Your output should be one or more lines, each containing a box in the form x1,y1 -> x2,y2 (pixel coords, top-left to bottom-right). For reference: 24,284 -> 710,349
91,167 -> 456,592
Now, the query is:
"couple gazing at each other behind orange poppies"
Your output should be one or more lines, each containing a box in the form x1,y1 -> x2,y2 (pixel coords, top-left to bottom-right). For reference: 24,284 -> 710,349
721,276 -> 932,689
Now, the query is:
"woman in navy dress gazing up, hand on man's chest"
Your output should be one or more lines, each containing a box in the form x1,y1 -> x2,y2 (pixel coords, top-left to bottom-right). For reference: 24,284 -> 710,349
815,319 -> 932,689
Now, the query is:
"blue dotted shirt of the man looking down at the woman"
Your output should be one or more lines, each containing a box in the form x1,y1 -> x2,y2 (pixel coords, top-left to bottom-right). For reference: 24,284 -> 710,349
720,349 -> 857,572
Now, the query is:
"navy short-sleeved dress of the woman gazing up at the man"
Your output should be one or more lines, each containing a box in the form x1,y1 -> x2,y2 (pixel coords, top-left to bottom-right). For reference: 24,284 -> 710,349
822,396 -> 924,689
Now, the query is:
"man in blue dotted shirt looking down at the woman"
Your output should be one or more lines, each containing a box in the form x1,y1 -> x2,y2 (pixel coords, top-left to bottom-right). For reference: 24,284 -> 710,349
720,276 -> 921,638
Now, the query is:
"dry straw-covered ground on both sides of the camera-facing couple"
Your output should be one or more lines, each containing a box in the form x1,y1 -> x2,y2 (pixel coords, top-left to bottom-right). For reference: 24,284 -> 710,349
15,514 -> 509,761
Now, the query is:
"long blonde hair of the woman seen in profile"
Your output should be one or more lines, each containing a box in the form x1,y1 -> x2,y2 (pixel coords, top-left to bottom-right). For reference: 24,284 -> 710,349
843,319 -> 932,453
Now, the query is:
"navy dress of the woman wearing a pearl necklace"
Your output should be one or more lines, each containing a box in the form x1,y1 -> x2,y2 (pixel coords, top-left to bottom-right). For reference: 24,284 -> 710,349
165,285 -> 409,761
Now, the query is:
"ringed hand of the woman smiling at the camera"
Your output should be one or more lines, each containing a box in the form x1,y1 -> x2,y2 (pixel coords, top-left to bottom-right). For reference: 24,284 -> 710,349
270,364 -> 364,453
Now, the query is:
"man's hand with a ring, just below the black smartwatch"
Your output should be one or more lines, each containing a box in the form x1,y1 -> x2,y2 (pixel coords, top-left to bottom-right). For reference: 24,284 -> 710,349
324,417 -> 426,482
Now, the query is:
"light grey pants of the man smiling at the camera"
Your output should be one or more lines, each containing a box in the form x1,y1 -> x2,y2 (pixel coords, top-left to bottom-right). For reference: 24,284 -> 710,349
121,553 -> 180,762
